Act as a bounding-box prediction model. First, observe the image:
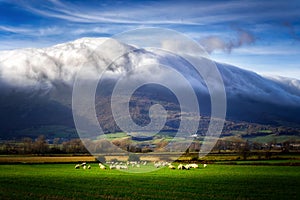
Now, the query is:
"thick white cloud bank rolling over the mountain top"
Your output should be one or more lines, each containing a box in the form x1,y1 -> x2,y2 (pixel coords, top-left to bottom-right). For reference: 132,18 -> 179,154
0,37 -> 300,108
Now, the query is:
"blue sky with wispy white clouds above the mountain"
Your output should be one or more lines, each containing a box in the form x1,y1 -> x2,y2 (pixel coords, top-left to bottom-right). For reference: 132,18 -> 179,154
0,0 -> 300,79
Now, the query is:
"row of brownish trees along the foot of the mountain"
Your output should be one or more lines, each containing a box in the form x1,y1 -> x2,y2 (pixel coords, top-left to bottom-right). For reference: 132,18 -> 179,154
0,135 -> 300,155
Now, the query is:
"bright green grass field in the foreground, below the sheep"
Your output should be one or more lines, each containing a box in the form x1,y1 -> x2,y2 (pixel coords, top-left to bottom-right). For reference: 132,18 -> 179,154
0,163 -> 300,199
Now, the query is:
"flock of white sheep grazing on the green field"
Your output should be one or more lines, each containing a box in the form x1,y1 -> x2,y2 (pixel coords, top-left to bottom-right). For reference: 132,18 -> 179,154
75,161 -> 207,170
